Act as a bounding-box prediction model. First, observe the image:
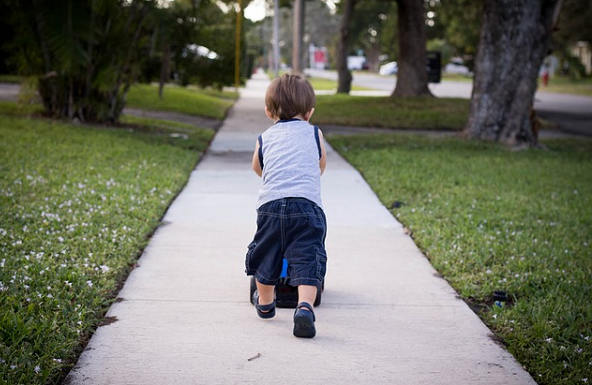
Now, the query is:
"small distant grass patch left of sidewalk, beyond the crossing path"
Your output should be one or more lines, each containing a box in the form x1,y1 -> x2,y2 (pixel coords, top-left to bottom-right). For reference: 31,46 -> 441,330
126,84 -> 238,120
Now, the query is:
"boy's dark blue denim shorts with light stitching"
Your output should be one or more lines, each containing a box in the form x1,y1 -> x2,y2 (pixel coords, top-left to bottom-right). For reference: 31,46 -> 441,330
245,198 -> 327,286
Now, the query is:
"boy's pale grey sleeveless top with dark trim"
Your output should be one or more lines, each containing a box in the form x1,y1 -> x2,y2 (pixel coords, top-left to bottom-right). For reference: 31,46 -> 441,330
257,119 -> 323,208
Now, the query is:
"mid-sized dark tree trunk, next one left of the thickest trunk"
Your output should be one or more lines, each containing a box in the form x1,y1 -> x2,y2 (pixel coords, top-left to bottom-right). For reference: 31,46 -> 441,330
392,0 -> 432,97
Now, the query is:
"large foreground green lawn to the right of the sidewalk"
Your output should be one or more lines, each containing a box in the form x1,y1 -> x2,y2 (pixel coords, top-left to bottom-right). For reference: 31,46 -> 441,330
328,135 -> 592,385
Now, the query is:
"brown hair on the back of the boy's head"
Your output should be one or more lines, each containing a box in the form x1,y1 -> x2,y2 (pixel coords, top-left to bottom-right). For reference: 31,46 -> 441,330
265,74 -> 316,120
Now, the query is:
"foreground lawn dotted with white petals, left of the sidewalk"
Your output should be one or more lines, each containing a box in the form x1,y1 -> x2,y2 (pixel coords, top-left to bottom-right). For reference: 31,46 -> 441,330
0,103 -> 214,384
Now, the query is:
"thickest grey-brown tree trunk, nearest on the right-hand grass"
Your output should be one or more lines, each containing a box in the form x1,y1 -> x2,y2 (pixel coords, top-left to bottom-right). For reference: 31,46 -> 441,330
465,0 -> 561,147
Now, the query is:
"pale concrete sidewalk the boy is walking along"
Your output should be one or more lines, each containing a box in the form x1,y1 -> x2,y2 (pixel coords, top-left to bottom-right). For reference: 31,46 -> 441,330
66,72 -> 535,385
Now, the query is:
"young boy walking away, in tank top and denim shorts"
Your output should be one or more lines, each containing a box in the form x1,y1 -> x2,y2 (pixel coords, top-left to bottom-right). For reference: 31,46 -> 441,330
245,75 -> 327,338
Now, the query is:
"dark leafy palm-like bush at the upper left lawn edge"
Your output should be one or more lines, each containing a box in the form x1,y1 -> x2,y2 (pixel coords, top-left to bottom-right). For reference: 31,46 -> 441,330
2,0 -> 160,122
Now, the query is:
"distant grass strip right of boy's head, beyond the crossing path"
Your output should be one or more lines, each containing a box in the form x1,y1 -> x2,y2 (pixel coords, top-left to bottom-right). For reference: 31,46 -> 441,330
313,95 -> 469,131
